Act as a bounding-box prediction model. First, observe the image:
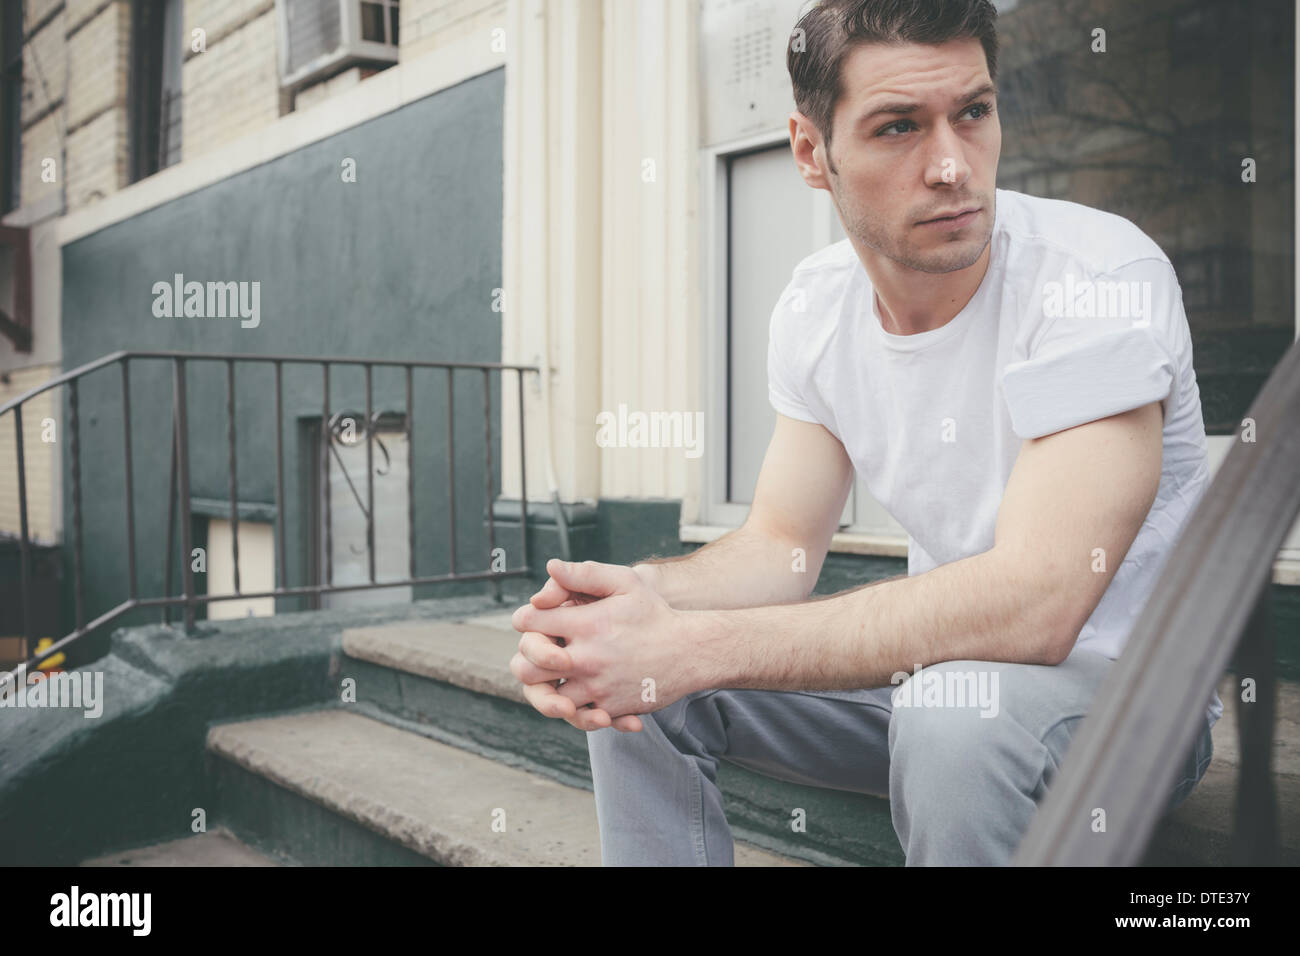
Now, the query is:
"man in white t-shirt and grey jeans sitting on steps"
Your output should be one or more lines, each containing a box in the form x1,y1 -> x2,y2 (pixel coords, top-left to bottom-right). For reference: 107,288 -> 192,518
511,0 -> 1222,865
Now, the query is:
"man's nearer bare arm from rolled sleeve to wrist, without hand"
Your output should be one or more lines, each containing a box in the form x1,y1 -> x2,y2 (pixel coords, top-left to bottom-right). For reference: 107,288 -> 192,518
684,403 -> 1161,689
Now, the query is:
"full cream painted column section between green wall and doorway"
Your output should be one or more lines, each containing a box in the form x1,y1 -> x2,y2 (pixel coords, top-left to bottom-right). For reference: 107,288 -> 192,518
502,0 -> 702,514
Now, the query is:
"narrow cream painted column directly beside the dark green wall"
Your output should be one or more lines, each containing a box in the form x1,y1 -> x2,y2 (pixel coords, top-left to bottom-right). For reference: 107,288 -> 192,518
501,0 -> 603,501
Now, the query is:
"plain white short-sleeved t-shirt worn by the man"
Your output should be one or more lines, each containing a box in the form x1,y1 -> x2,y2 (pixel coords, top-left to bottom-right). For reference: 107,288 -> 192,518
767,189 -> 1223,723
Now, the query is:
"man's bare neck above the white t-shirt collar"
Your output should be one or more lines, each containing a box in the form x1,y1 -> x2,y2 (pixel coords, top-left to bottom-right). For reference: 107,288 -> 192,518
854,242 -> 993,336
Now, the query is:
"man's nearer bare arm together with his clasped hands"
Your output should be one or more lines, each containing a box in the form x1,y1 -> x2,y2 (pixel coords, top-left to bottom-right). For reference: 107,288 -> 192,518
511,403 -> 1161,730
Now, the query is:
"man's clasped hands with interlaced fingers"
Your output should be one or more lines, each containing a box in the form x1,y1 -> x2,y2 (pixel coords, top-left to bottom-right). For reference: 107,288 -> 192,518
510,558 -> 696,731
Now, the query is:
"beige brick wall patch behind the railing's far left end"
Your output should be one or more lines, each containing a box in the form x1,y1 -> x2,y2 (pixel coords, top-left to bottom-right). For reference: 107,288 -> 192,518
0,365 -> 62,544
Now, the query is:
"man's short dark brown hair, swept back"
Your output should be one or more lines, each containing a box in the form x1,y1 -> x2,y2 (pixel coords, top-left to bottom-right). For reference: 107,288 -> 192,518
785,0 -> 997,146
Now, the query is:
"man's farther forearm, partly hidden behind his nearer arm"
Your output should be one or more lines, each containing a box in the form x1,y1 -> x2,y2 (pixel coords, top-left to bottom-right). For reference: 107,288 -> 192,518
633,524 -> 820,610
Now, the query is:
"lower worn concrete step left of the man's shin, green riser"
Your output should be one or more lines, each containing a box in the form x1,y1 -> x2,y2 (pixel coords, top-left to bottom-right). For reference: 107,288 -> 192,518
207,705 -> 800,866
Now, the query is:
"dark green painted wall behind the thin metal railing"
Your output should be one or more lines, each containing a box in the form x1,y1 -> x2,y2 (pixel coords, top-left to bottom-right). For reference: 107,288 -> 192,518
61,69 -> 512,654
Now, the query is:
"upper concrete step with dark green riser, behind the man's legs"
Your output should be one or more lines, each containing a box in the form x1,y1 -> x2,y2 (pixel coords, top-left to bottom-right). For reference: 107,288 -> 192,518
343,610 -> 1300,865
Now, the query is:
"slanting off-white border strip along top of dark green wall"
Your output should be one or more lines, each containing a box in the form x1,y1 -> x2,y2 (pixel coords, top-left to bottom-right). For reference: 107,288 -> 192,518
56,36 -> 506,247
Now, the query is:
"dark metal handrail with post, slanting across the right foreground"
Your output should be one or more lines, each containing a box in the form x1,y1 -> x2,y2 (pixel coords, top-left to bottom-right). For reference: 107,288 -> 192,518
1013,342 -> 1300,866
